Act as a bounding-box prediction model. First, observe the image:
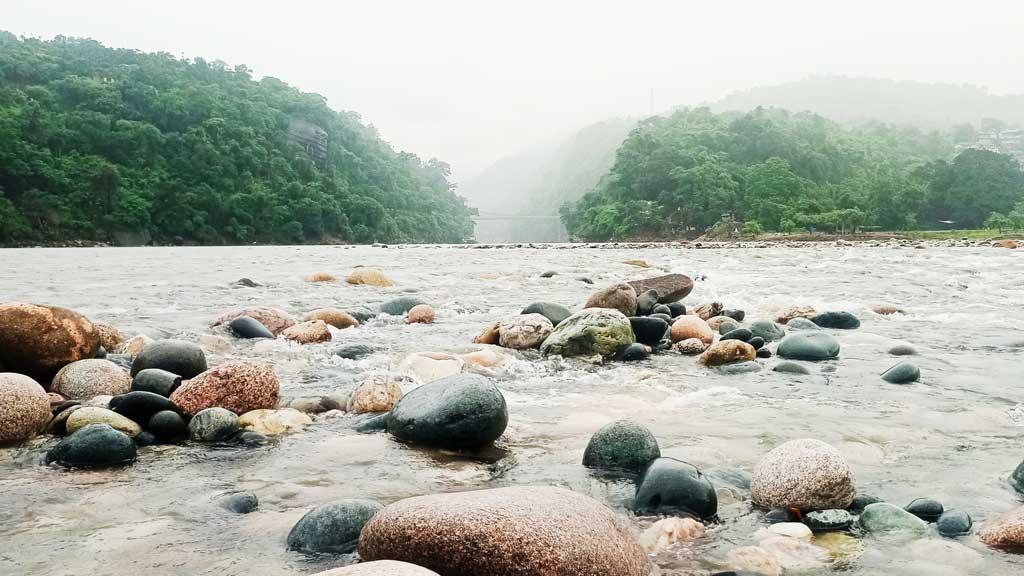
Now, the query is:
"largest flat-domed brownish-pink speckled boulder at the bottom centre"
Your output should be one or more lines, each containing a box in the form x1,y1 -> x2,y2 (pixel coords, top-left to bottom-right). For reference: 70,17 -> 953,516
358,486 -> 650,576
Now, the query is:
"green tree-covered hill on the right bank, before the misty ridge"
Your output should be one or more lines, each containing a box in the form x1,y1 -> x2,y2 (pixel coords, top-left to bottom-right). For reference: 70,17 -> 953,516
561,109 -> 1024,240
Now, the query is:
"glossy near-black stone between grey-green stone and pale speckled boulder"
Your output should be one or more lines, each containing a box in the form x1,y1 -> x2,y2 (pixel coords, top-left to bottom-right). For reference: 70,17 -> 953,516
633,458 -> 718,520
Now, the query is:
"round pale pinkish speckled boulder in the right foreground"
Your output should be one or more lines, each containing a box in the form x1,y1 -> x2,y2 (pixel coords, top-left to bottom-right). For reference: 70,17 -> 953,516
751,439 -> 856,511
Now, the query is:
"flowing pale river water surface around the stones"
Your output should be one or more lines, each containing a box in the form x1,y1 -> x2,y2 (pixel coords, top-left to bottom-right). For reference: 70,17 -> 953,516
0,245 -> 1024,576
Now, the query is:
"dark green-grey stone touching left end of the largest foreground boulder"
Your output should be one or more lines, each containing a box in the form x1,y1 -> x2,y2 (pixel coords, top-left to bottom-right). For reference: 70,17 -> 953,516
288,499 -> 384,553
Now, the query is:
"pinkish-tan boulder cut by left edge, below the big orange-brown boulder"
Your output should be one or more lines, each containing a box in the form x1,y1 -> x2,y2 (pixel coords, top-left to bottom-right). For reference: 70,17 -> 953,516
0,372 -> 50,445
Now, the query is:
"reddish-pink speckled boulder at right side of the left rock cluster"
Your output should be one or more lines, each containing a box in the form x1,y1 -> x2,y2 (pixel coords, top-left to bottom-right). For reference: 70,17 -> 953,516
171,361 -> 281,414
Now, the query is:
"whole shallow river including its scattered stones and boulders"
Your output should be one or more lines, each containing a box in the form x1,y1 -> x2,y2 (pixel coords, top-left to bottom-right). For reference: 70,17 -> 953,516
0,241 -> 1024,576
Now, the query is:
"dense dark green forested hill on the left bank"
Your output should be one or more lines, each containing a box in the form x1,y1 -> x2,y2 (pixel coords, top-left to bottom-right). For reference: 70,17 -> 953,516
0,32 -> 472,244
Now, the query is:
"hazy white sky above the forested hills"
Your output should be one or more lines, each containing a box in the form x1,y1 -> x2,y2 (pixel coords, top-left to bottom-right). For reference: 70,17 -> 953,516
6,0 -> 1024,177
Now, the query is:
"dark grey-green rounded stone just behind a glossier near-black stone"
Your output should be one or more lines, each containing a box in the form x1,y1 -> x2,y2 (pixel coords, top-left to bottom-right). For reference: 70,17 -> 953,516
583,420 -> 662,472
